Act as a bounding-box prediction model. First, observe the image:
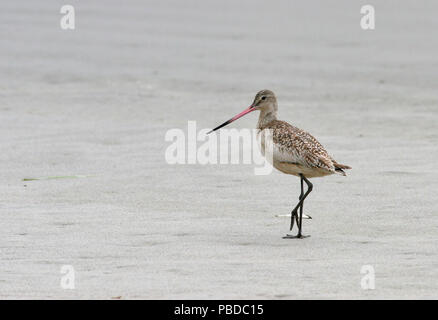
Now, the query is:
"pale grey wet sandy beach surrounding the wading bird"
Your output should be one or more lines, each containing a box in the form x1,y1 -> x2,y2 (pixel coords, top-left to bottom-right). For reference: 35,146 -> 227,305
0,0 -> 438,299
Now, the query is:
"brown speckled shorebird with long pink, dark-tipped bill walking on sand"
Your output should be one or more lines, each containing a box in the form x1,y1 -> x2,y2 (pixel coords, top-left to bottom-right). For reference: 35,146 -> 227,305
208,90 -> 351,239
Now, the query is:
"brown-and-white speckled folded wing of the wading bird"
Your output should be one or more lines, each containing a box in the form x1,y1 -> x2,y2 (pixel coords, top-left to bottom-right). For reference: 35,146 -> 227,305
263,120 -> 335,172
